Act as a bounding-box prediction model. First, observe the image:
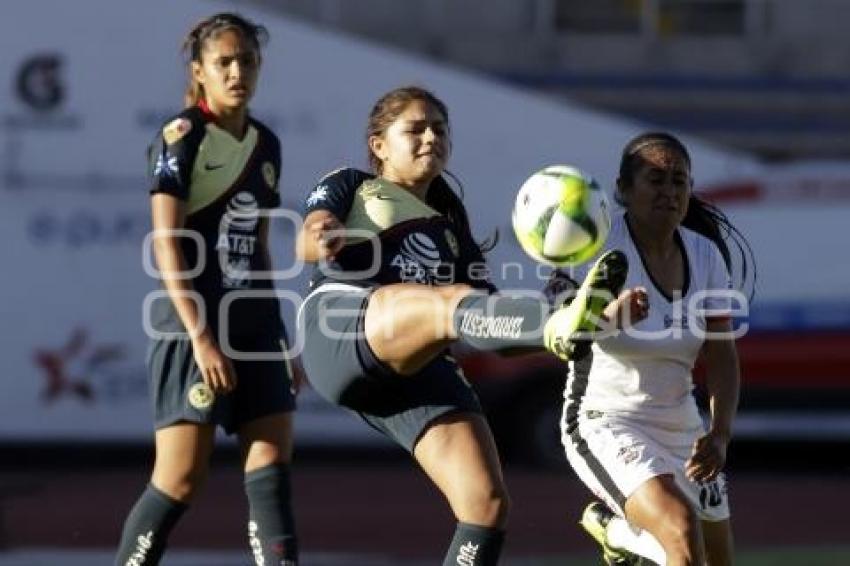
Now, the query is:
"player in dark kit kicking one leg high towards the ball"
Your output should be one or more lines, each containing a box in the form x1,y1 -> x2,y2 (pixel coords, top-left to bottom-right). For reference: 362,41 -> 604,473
297,87 -> 626,566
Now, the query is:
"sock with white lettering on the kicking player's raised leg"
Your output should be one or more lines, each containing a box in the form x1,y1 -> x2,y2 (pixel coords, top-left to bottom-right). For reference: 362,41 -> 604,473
454,293 -> 551,351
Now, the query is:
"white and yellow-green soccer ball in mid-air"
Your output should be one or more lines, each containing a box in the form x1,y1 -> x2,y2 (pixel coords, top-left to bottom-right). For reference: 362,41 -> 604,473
513,165 -> 611,267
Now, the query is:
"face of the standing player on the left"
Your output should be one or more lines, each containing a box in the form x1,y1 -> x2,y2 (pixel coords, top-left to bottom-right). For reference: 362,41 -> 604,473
192,29 -> 260,114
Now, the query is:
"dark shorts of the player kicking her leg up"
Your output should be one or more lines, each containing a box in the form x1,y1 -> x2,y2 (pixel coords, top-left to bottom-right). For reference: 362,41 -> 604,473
298,283 -> 482,452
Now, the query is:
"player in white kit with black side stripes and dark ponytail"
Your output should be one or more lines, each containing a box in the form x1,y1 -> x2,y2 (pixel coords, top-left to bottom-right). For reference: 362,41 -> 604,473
561,133 -> 749,566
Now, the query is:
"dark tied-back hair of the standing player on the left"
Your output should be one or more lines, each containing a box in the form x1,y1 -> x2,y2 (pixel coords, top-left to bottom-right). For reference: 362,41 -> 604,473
181,12 -> 269,108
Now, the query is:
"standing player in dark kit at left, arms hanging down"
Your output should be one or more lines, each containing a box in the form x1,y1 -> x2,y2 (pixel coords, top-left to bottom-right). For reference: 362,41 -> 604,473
115,13 -> 298,566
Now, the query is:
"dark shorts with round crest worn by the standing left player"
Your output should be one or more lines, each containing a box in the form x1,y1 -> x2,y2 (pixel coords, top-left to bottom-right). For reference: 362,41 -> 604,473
147,334 -> 295,434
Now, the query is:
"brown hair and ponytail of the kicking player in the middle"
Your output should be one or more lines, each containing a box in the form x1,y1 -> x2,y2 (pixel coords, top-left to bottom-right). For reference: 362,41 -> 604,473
366,86 -> 498,252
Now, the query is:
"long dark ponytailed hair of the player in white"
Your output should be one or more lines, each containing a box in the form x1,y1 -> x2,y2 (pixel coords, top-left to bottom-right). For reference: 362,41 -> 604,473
616,132 -> 757,299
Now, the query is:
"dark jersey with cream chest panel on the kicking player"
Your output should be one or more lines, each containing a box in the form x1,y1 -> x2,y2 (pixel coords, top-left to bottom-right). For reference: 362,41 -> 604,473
304,168 -> 495,291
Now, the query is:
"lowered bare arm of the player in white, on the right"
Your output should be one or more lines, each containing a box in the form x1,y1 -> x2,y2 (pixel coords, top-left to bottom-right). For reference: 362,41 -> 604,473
685,317 -> 741,481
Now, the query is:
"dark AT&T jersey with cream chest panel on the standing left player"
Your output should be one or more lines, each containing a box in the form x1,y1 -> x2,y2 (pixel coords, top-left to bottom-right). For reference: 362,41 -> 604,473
150,106 -> 282,335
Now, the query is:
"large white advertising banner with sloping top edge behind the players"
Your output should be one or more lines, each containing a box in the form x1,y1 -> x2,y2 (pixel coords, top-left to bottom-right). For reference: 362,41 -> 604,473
0,0 -> 776,440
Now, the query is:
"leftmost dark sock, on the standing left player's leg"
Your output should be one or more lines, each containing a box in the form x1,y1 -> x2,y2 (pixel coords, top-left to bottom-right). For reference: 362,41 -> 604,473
115,484 -> 188,566
